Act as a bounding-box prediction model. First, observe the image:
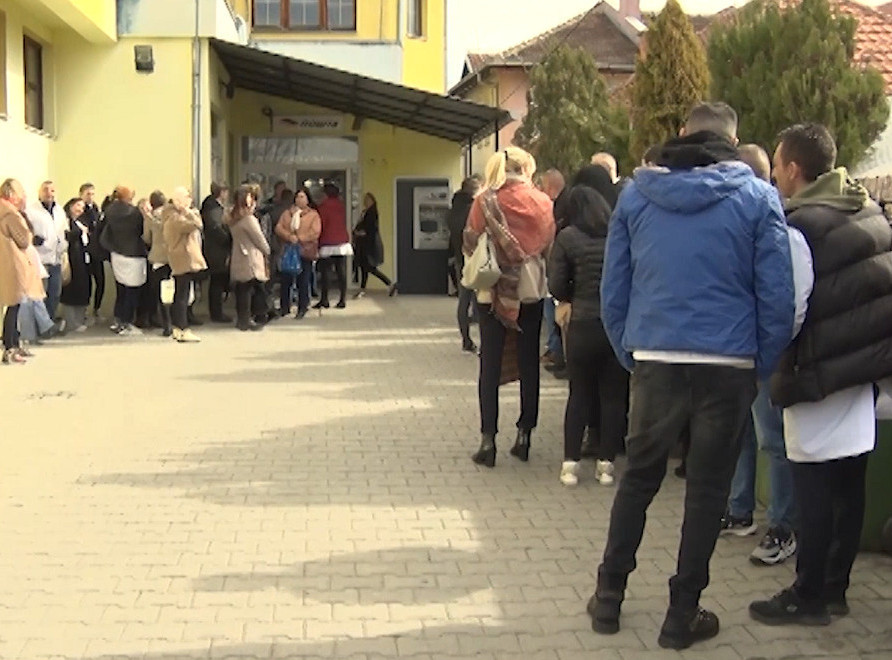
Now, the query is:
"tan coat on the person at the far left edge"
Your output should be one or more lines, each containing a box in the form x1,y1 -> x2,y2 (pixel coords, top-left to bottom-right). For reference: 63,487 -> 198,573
0,199 -> 45,307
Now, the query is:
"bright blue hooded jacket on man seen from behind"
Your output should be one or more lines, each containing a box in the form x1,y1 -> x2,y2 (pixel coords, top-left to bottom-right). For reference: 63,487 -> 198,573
601,161 -> 794,378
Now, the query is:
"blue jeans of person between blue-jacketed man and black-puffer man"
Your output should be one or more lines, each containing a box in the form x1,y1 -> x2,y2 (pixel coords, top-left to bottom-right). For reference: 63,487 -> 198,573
728,383 -> 796,530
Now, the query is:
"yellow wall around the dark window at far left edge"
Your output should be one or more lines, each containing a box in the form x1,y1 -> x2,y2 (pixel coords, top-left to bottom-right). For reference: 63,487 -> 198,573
0,0 -> 53,199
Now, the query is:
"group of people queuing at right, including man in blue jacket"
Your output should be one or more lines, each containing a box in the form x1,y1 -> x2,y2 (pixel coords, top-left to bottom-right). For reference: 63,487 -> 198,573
449,103 -> 892,649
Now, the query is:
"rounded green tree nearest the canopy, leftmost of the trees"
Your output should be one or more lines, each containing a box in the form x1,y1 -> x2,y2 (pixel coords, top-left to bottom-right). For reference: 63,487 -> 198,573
514,46 -> 628,177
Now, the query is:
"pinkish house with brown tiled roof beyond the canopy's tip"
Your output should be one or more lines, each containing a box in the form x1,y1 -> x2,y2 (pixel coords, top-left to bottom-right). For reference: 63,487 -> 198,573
450,0 -> 645,173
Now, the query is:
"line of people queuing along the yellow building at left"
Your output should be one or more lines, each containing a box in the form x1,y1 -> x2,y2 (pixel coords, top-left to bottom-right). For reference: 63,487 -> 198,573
0,179 -> 397,364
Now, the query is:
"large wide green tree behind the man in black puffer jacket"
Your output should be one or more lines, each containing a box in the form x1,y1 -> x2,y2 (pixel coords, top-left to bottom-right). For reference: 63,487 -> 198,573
708,0 -> 889,166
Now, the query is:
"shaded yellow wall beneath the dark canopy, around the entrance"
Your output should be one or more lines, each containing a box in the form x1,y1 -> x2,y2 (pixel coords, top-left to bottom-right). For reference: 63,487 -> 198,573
222,80 -> 462,288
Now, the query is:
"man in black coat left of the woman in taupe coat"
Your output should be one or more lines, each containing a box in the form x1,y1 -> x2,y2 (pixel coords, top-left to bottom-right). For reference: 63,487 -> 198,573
201,183 -> 232,323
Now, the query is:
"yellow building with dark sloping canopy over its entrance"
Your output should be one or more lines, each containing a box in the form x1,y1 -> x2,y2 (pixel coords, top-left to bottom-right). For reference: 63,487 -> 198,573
0,0 -> 507,293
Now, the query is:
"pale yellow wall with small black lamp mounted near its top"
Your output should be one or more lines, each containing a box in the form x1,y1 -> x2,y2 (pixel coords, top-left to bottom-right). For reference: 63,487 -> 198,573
50,37 -> 192,197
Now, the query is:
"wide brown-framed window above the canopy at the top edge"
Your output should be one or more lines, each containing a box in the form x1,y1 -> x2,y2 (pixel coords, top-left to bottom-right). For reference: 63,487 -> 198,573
254,0 -> 356,30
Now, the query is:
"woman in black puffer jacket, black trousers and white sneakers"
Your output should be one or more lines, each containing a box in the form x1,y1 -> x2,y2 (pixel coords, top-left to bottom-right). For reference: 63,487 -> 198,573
548,183 -> 628,486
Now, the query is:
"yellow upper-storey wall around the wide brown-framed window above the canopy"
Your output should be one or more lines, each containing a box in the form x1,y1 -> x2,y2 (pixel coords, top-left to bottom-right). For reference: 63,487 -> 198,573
233,0 -> 399,42
